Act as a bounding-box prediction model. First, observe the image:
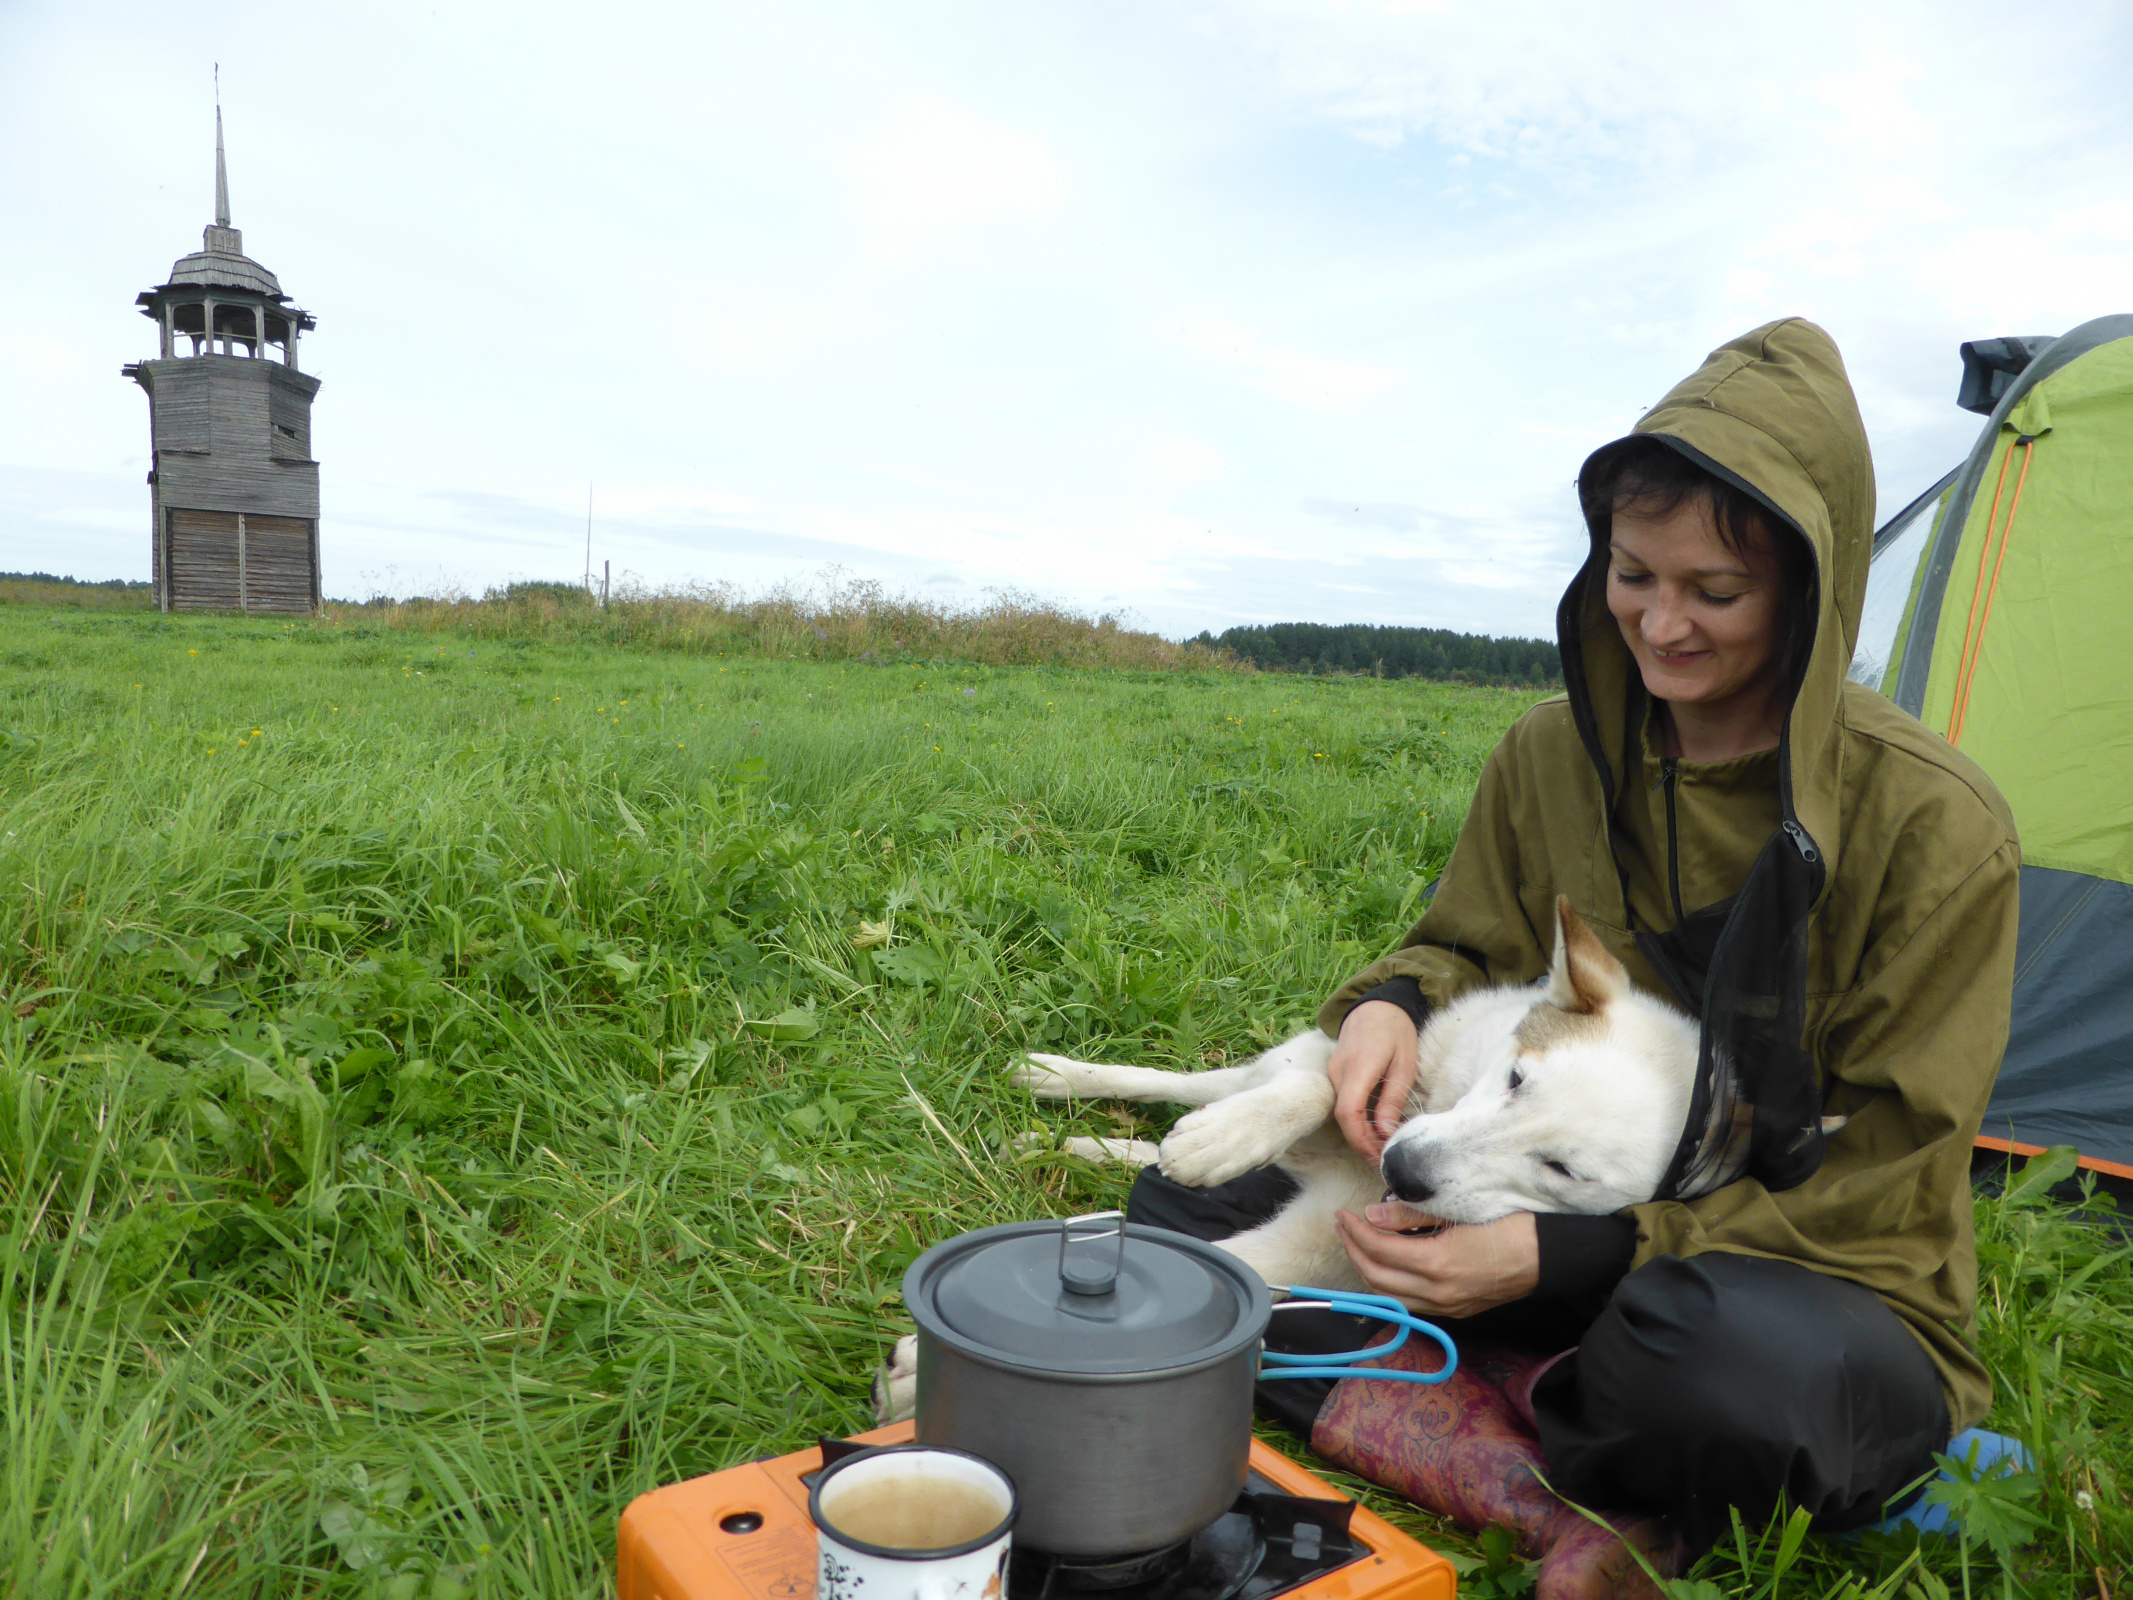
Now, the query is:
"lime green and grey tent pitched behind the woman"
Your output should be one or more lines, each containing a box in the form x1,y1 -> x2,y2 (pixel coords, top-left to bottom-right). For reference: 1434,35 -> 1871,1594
1851,316 -> 2133,1178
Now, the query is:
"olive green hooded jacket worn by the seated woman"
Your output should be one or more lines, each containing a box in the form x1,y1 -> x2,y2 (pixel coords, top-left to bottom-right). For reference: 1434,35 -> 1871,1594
1318,320 -> 2020,1429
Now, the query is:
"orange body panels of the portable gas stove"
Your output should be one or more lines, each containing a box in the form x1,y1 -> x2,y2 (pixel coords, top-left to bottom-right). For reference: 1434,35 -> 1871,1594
614,1423 -> 1459,1600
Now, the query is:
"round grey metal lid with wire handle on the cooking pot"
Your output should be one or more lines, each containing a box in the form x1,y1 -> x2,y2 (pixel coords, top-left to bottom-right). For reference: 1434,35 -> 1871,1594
904,1212 -> 1269,1376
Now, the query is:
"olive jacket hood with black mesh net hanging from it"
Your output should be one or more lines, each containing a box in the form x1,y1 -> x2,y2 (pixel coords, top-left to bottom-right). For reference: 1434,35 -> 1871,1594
1555,318 -> 1873,1197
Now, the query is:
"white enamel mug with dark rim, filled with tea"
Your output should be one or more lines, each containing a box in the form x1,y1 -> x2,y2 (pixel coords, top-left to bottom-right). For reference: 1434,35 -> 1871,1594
806,1444 -> 1020,1600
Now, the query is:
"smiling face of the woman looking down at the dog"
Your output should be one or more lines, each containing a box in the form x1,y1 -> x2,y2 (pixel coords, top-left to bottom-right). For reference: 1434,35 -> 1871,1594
1606,495 -> 1785,715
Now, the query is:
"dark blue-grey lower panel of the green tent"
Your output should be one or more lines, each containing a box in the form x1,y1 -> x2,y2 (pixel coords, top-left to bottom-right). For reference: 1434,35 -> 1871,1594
1984,866 -> 2133,1167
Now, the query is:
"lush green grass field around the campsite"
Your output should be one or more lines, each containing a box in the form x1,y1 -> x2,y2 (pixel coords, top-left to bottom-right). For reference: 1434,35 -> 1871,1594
0,606 -> 2133,1600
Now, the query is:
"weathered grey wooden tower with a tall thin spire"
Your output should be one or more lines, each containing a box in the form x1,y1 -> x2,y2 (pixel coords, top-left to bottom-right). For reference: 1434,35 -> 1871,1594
124,107 -> 320,612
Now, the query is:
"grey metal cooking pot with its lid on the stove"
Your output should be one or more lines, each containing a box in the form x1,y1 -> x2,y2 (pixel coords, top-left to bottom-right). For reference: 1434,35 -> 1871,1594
904,1212 -> 1271,1557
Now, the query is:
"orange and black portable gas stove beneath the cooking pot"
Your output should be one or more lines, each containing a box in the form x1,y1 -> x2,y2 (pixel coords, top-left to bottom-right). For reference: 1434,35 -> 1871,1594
614,1423 -> 1459,1600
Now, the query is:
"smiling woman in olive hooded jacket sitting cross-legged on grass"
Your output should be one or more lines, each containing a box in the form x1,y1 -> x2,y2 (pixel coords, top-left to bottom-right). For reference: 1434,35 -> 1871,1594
1133,320 -> 2018,1600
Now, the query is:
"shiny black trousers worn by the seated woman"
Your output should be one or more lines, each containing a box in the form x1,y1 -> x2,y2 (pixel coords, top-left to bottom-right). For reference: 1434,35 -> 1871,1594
1126,1167 -> 1950,1551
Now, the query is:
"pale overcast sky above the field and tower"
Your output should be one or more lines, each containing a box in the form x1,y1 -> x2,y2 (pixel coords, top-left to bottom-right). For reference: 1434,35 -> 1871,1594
0,0 -> 2133,636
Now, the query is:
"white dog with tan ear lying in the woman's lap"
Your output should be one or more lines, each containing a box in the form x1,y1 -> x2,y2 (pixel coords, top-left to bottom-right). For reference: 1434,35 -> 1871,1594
877,898 -> 1698,1419
